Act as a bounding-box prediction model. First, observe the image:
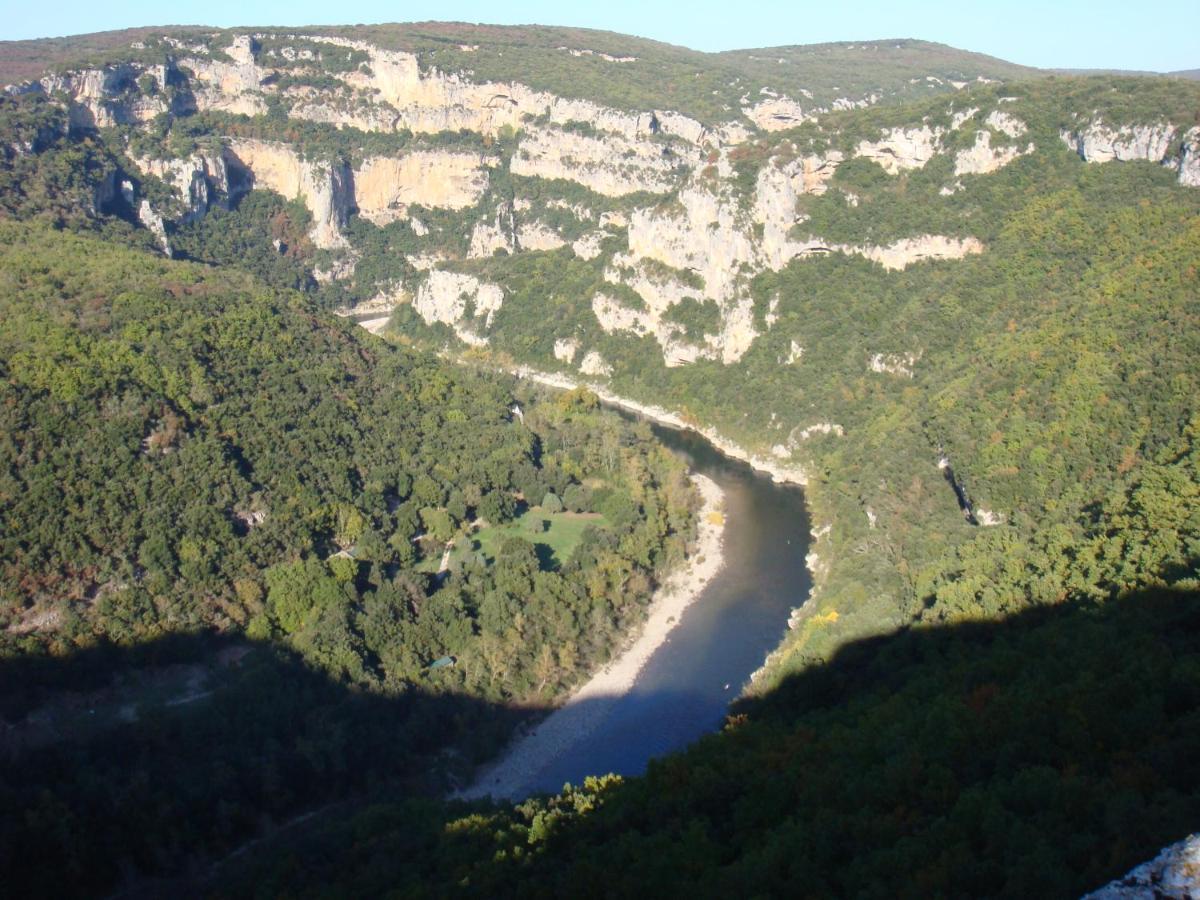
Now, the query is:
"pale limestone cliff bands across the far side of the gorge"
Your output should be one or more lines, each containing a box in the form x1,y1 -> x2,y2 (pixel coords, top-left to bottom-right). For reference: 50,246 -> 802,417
14,34 -> 1200,373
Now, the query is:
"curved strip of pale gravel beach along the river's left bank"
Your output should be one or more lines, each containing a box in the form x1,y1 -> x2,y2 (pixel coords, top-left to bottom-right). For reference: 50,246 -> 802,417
454,474 -> 725,800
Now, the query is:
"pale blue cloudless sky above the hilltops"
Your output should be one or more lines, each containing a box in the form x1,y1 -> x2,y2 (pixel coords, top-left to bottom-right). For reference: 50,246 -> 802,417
0,0 -> 1200,71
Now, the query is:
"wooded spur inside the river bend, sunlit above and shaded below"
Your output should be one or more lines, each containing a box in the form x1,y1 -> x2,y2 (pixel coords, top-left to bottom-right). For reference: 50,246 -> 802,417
0,222 -> 695,893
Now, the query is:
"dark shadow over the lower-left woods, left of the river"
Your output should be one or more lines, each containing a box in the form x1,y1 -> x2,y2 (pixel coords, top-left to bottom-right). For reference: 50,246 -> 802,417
0,636 -> 552,898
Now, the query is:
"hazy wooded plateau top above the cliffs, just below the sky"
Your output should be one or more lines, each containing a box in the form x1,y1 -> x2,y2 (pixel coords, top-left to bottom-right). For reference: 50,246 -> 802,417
0,22 -> 1037,124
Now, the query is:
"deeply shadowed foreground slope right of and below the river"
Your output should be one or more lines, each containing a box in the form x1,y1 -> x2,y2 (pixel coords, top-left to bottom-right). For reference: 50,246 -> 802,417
208,590 -> 1200,898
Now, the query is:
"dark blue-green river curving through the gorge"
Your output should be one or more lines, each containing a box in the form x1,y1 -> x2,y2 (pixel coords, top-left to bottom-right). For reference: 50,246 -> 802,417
516,410 -> 811,792
